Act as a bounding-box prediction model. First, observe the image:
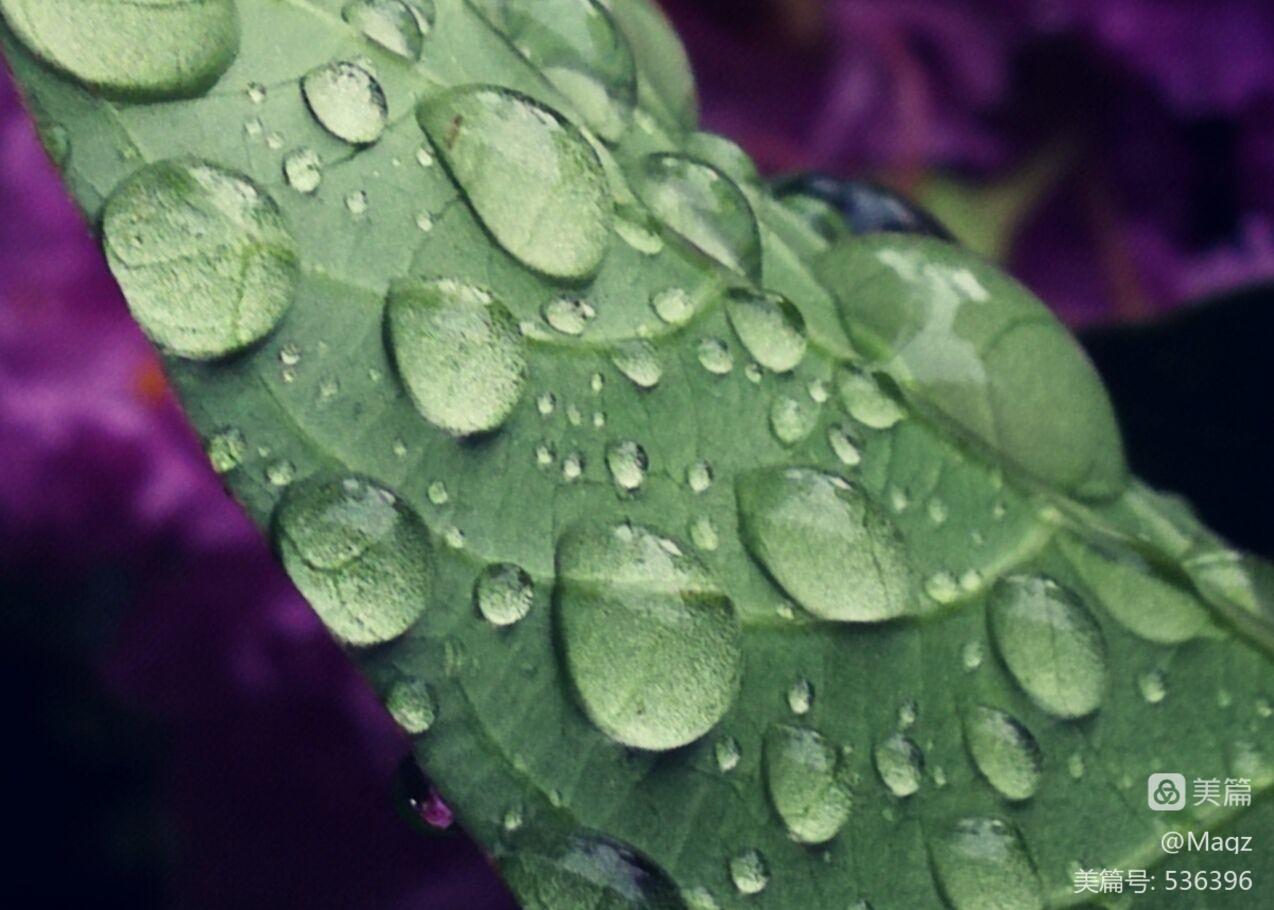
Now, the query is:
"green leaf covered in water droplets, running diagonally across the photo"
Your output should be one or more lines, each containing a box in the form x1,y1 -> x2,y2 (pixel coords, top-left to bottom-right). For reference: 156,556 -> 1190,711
0,0 -> 1274,910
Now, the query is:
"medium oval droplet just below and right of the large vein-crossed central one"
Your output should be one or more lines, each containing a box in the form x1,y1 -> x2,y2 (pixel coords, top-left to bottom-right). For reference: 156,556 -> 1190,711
764,724 -> 852,844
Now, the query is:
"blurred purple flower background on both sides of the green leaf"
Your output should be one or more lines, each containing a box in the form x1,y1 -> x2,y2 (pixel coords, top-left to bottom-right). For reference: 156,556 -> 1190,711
0,0 -> 1274,910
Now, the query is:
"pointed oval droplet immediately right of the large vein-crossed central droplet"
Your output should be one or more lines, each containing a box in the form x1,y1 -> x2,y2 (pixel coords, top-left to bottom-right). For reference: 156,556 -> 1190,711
735,468 -> 911,622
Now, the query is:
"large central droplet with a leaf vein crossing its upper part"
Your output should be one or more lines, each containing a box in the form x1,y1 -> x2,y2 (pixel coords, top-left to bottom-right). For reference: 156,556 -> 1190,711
555,525 -> 741,749
